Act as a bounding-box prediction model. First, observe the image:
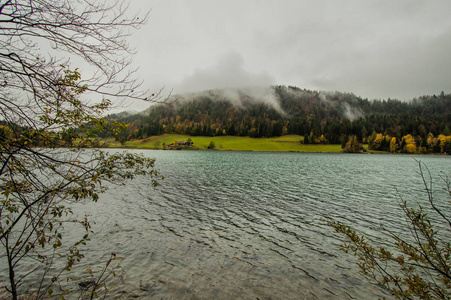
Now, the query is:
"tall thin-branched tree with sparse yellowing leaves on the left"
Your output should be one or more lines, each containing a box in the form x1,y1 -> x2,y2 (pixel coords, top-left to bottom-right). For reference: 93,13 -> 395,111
0,0 -> 166,299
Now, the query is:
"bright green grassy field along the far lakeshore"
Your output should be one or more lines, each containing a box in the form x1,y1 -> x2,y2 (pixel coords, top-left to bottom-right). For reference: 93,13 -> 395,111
102,134 -> 341,153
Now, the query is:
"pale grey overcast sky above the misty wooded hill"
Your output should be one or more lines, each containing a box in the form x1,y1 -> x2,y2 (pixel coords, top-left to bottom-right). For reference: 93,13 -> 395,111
124,0 -> 451,110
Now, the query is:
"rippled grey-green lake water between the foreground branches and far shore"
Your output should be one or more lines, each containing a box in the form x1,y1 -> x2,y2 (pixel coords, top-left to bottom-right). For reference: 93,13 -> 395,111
8,151 -> 451,299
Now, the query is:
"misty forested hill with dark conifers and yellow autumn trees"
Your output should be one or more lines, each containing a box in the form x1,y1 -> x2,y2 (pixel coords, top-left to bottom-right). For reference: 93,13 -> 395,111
101,86 -> 451,153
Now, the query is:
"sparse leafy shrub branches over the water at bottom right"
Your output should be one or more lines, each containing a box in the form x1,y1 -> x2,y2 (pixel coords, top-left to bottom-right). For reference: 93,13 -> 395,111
328,162 -> 451,299
